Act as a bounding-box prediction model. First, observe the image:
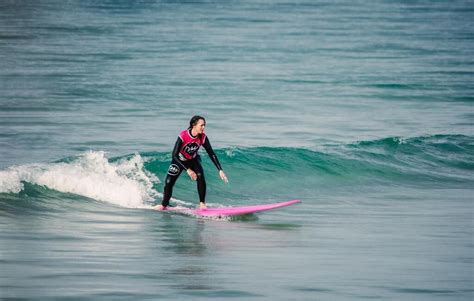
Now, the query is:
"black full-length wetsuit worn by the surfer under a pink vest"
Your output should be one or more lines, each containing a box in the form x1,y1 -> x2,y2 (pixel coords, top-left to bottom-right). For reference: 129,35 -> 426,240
161,130 -> 222,207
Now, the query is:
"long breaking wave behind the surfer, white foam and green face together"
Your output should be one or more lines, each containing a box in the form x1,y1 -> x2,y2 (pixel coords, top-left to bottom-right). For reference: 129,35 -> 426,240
0,135 -> 474,208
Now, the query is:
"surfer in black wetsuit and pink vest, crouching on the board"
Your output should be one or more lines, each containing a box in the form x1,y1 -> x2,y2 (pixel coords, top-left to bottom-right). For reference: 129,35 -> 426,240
154,116 -> 229,210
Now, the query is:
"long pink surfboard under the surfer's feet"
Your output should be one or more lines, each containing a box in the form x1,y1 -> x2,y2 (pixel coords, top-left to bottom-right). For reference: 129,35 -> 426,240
164,200 -> 301,217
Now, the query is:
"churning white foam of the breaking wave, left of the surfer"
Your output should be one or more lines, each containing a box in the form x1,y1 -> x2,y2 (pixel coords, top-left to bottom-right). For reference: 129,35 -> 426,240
0,151 -> 159,208
